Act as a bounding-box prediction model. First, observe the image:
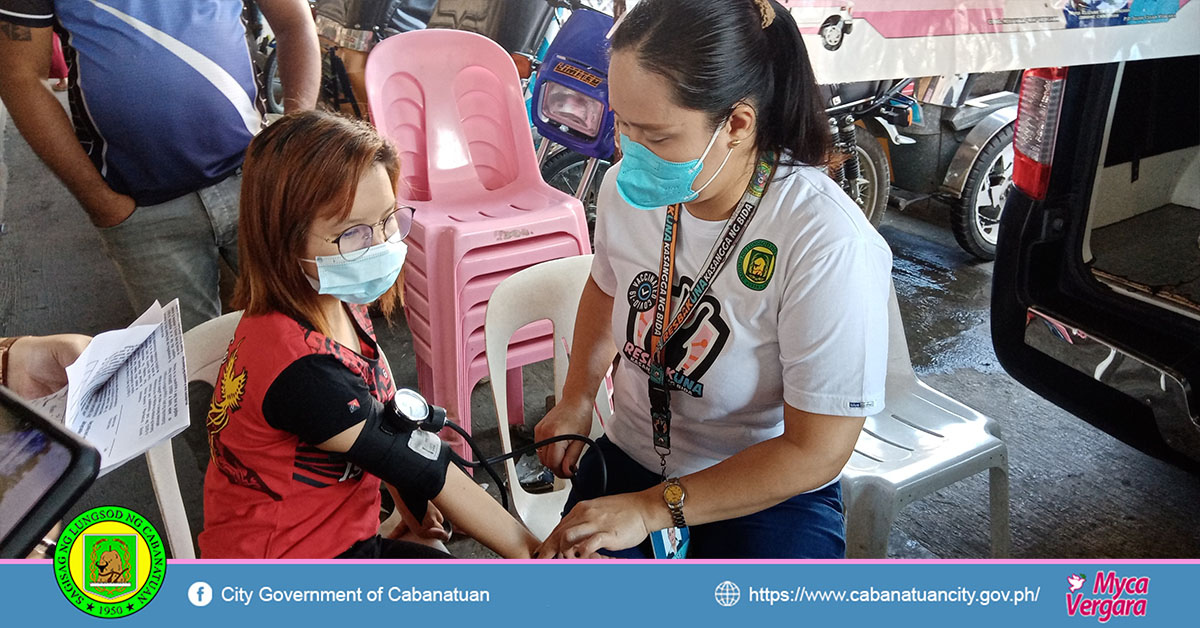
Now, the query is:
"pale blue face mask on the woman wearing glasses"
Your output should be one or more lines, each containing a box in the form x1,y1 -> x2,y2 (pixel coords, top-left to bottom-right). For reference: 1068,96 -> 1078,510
301,241 -> 408,305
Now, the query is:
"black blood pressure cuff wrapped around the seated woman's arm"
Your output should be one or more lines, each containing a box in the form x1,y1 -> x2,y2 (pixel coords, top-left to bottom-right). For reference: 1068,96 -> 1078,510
346,403 -> 450,521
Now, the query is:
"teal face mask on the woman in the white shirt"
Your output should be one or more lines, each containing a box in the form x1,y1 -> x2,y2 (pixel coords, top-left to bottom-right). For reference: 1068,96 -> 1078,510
617,124 -> 733,210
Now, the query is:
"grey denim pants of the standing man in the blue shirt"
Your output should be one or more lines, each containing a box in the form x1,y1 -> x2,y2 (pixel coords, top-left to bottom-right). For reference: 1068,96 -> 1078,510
98,171 -> 241,330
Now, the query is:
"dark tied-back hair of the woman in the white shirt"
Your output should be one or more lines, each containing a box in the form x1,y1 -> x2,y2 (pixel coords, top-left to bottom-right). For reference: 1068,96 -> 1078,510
612,0 -> 830,165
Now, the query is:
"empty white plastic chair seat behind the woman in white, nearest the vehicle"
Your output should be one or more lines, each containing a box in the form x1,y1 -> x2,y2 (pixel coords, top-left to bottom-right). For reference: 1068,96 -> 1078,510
841,287 -> 1012,558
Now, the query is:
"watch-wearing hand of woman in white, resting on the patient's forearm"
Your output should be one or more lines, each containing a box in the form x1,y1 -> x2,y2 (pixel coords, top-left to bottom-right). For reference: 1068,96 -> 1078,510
534,491 -> 665,558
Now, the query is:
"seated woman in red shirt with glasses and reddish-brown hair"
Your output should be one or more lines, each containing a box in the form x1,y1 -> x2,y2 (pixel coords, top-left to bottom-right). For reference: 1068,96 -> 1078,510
199,112 -> 538,558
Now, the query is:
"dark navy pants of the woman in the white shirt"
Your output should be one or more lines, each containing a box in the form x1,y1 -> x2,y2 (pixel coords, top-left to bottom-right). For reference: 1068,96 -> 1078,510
563,436 -> 846,558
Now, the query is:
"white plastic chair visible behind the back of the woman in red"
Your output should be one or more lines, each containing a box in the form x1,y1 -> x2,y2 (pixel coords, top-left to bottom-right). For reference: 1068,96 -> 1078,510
146,312 -> 241,558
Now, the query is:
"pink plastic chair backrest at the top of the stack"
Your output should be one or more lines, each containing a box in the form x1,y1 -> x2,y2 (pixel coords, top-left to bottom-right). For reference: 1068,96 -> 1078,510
366,29 -> 541,202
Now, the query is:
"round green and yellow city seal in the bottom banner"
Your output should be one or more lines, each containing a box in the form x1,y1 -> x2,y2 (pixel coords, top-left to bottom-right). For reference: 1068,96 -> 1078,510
54,506 -> 167,617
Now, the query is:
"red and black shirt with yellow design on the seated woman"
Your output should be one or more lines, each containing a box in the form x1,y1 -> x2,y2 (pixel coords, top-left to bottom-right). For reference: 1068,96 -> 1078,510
199,306 -> 396,558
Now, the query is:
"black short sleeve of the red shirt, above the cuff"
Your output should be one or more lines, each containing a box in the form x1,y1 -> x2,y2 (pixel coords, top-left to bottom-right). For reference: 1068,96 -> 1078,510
263,355 -> 383,447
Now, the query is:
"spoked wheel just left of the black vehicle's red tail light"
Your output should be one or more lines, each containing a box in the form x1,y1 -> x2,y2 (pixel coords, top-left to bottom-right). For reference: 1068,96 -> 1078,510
950,125 -> 1014,262
